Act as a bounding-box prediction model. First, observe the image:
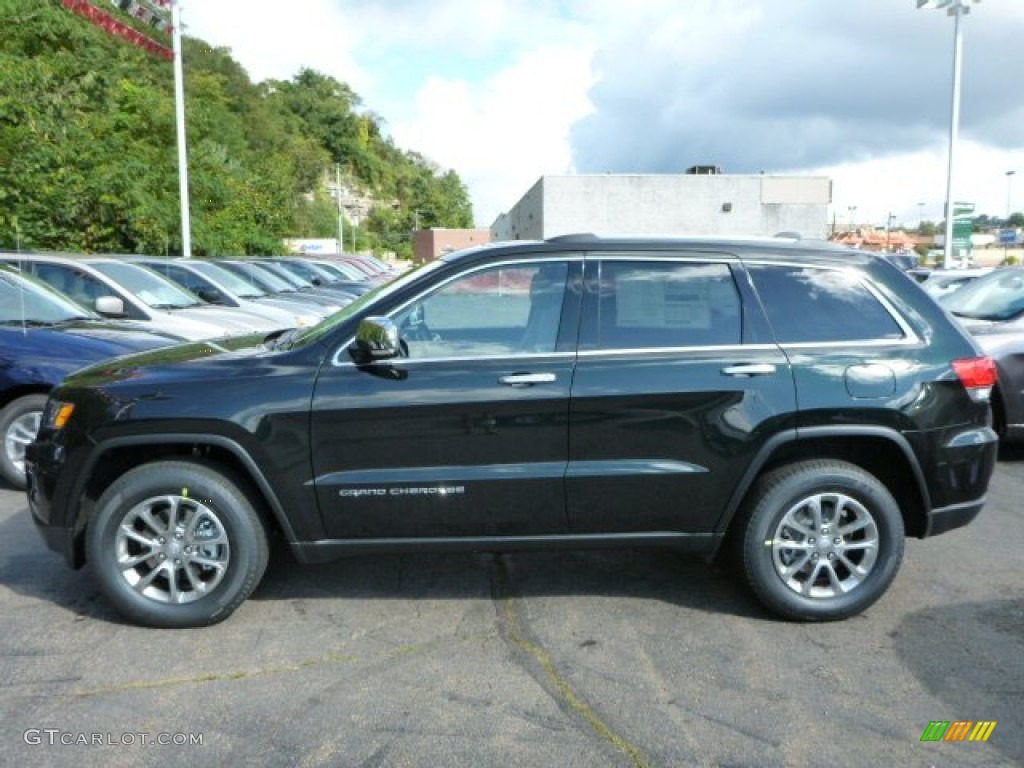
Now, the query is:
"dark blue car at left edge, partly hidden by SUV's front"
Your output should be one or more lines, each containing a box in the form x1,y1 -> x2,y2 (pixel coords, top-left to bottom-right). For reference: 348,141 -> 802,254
0,268 -> 180,488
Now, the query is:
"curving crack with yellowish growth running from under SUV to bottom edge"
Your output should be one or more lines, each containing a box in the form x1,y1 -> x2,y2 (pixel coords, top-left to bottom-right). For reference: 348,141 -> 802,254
492,555 -> 651,768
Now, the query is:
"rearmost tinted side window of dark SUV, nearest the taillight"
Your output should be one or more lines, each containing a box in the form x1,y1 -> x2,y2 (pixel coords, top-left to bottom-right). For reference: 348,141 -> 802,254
748,265 -> 904,344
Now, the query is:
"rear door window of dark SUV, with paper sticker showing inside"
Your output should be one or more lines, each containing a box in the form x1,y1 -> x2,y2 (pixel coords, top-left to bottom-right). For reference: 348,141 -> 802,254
583,261 -> 742,349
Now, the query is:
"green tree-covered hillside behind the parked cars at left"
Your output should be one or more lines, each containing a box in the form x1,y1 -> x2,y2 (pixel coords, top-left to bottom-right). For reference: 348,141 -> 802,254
0,0 -> 473,256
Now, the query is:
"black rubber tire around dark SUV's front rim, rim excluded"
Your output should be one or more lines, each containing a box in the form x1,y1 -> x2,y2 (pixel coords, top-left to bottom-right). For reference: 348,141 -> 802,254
86,462 -> 268,629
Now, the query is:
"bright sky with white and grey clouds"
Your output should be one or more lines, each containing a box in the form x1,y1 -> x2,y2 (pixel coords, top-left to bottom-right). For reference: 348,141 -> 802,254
180,0 -> 1024,227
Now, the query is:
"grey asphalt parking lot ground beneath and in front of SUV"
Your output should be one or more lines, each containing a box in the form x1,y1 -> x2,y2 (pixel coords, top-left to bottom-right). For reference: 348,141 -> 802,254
0,451 -> 1024,768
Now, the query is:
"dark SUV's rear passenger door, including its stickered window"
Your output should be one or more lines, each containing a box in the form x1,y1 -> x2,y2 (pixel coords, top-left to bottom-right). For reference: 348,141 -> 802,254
566,253 -> 796,541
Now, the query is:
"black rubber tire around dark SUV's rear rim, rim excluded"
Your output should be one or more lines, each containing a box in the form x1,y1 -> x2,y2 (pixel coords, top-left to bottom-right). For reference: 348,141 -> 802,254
742,462 -> 904,621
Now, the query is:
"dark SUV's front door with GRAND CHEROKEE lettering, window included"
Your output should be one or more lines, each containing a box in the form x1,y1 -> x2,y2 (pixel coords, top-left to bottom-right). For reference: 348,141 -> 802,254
311,258 -> 582,539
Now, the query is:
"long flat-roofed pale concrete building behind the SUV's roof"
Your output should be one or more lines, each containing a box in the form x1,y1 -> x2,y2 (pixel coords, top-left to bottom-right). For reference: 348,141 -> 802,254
490,173 -> 831,241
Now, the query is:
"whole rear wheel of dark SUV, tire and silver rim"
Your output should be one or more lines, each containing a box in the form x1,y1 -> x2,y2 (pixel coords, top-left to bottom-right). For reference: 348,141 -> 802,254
741,460 -> 904,622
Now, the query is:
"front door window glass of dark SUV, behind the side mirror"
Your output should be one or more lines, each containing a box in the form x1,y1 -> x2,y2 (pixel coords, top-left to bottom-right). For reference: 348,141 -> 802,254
393,262 -> 568,359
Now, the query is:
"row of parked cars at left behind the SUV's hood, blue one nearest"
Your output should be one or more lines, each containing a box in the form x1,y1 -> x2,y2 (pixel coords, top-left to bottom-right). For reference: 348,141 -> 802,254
0,253 -> 392,486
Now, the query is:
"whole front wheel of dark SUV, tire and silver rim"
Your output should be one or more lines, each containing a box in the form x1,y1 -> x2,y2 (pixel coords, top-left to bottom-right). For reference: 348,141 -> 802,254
86,461 -> 268,629
